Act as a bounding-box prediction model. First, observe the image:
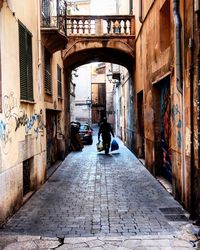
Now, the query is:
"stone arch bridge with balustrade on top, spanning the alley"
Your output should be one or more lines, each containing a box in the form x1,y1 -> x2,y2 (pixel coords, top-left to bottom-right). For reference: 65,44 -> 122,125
63,15 -> 135,69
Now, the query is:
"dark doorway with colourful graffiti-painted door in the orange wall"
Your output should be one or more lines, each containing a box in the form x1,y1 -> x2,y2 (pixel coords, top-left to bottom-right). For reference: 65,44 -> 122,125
153,76 -> 172,183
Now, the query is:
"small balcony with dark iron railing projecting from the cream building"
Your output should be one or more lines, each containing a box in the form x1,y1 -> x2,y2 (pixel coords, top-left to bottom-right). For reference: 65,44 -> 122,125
40,0 -> 67,53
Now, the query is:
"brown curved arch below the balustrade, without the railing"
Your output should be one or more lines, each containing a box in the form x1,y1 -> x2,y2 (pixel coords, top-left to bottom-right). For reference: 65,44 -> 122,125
63,37 -> 135,69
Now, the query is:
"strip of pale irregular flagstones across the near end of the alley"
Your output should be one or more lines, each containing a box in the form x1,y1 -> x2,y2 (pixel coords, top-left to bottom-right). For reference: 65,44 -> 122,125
0,235 -> 200,250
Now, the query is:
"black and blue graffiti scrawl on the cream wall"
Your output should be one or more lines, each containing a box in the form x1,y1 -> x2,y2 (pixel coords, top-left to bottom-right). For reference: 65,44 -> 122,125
0,92 -> 45,153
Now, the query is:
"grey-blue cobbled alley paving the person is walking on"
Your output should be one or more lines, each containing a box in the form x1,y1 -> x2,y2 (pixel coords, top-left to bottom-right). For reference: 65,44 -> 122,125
0,131 -> 200,250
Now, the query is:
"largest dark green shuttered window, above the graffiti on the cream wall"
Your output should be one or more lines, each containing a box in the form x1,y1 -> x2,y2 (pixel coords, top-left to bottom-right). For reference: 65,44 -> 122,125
19,22 -> 33,101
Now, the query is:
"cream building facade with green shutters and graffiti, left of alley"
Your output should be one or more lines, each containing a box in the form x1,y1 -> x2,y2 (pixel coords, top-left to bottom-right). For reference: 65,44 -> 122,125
0,0 -> 65,224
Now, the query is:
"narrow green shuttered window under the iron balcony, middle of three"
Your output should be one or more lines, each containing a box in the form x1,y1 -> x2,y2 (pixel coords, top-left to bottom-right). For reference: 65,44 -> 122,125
44,49 -> 52,94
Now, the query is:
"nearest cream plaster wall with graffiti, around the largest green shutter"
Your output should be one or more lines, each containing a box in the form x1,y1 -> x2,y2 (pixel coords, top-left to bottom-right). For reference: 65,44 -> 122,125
0,0 -> 46,223
